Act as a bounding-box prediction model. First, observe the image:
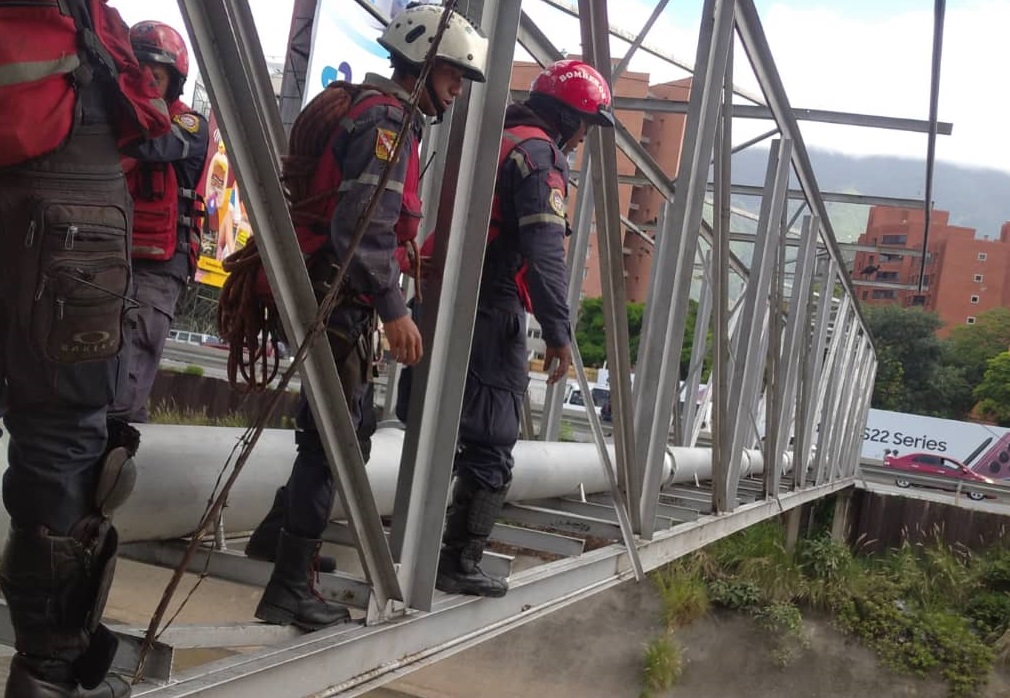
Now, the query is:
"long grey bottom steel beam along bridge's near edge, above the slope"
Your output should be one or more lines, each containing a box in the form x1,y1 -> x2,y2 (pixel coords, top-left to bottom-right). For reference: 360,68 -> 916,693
133,481 -> 851,698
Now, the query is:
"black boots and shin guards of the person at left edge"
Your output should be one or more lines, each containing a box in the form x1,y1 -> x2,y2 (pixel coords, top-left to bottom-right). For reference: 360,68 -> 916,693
0,516 -> 130,698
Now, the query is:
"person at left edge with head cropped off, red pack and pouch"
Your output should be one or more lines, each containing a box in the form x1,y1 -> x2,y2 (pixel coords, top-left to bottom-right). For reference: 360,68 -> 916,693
0,0 -> 169,698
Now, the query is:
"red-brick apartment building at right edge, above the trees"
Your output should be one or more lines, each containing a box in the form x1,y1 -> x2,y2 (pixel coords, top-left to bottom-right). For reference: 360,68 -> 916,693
852,206 -> 1010,336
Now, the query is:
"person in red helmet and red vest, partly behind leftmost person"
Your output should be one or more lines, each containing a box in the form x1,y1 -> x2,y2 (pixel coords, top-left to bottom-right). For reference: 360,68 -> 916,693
109,21 -> 209,422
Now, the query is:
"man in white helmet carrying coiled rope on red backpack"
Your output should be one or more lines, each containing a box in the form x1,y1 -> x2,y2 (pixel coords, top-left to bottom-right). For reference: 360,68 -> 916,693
246,5 -> 487,629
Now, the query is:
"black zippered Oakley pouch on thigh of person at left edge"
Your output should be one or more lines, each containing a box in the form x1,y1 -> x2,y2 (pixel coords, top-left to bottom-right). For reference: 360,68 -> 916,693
24,198 -> 130,364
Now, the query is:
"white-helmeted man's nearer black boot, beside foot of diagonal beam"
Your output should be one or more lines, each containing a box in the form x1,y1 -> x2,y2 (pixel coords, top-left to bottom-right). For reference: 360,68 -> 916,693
256,529 -> 350,630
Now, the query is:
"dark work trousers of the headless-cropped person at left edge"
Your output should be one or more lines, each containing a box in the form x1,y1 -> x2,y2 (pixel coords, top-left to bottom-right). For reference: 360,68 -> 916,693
0,125 -> 131,535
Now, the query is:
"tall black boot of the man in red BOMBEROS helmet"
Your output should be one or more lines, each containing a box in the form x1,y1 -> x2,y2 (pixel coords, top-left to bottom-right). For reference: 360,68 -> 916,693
435,477 -> 508,597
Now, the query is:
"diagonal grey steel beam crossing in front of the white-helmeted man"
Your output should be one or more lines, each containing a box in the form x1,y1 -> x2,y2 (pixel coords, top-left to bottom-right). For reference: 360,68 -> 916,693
180,0 -> 401,610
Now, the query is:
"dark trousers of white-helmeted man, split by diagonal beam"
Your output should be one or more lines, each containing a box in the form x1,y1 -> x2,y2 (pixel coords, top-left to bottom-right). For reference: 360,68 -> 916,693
284,304 -> 376,538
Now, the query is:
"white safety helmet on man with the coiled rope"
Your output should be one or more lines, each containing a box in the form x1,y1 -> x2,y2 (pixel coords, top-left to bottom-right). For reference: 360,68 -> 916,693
379,5 -> 488,83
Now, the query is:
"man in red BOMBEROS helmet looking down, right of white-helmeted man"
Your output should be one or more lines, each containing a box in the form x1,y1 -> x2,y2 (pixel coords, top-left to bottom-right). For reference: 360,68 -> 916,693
435,61 -> 613,596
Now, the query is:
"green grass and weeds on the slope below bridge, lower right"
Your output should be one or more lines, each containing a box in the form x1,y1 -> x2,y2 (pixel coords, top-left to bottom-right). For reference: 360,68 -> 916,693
642,521 -> 1010,696
